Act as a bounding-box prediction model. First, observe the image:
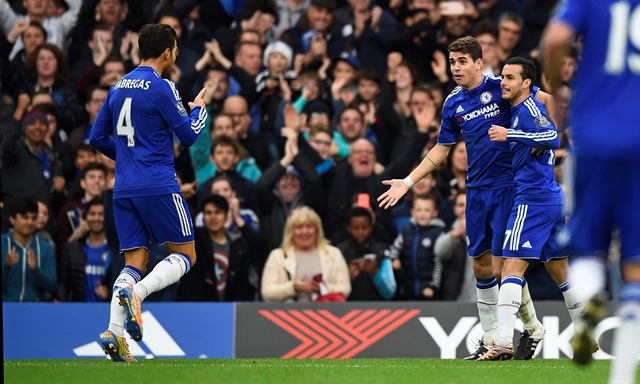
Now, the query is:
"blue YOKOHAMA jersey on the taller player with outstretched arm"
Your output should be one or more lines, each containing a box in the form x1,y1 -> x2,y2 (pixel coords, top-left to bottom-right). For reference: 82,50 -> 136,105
438,76 -> 513,189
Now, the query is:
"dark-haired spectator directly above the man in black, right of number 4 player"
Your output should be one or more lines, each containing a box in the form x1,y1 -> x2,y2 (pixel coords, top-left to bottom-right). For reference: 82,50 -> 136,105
196,136 -> 254,212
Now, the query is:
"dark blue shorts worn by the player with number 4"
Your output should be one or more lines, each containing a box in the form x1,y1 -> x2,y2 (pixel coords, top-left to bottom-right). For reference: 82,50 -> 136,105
113,193 -> 193,251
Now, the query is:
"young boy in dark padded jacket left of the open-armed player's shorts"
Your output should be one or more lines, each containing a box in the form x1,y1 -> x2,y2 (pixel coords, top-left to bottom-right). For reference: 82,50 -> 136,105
389,195 -> 444,300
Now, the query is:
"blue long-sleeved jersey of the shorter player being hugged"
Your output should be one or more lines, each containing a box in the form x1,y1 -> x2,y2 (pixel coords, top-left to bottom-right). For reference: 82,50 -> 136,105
507,95 -> 564,205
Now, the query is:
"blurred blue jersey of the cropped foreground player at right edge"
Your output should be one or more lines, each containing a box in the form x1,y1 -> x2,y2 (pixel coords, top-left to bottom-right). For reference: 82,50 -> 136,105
554,0 -> 640,159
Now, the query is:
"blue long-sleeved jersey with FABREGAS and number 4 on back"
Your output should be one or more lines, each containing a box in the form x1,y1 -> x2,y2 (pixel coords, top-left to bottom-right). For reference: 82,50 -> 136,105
90,66 -> 207,198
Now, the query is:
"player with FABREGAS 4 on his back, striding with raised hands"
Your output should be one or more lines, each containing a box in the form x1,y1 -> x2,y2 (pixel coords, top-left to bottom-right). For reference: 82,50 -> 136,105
90,24 -> 207,361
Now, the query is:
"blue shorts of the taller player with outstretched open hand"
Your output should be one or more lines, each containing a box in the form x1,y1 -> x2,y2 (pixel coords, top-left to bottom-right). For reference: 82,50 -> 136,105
465,187 -> 513,258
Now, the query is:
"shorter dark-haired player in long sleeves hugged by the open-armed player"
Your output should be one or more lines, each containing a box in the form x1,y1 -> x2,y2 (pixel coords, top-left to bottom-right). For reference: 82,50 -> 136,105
478,57 -> 597,360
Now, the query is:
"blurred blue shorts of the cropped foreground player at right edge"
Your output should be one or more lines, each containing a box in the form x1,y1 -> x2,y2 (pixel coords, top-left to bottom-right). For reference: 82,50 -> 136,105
567,154 -> 640,264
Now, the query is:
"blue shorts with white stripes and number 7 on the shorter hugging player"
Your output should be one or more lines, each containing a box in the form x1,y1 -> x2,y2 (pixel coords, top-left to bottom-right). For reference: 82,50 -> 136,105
502,204 -> 567,261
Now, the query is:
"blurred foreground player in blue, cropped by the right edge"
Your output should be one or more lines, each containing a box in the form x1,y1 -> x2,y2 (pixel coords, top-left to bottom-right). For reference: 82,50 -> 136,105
543,0 -> 640,383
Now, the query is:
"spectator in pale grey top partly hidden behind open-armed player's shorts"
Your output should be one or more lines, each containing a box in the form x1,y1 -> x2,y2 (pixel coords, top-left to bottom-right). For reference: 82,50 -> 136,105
433,189 -> 478,303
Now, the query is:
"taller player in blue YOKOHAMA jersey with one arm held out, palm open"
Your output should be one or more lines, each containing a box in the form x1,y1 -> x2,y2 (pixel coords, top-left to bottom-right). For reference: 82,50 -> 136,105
378,37 -> 550,360
